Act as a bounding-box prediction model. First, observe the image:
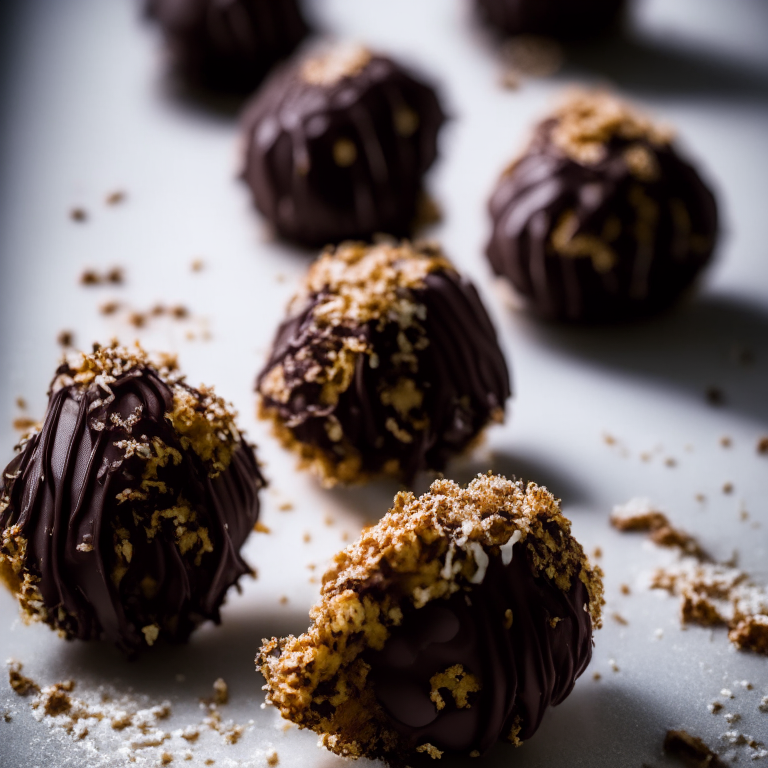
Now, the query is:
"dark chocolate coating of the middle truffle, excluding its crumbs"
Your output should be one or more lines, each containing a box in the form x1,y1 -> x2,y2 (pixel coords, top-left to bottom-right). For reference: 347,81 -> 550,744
257,243 -> 510,482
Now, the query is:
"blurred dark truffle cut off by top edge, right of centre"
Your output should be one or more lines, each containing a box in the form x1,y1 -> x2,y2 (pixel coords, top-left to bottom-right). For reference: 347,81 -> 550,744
475,0 -> 626,40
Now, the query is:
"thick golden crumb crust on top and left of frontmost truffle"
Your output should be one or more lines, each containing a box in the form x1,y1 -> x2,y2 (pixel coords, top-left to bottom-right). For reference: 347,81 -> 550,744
257,474 -> 603,757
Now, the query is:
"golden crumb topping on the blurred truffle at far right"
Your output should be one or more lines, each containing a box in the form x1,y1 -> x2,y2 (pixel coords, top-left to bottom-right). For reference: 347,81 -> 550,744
551,91 -> 673,166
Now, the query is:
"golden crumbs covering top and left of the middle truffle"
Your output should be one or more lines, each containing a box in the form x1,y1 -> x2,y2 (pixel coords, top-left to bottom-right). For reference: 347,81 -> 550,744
259,242 -> 452,486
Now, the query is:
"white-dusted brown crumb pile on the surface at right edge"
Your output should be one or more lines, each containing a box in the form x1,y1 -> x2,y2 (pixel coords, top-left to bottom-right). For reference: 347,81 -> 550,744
611,499 -> 768,656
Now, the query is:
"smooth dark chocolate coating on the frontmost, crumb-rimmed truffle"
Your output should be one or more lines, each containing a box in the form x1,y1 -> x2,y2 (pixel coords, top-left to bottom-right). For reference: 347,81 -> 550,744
367,549 -> 592,754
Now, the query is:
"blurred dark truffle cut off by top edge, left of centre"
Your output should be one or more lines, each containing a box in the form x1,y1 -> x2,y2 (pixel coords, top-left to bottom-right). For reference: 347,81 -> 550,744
146,0 -> 308,93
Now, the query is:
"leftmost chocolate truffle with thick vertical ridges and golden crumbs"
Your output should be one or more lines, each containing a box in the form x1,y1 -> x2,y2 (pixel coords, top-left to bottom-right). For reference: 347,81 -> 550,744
0,344 -> 264,653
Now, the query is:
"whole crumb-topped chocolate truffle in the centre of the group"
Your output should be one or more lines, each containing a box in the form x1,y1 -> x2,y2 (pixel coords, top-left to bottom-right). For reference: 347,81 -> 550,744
257,242 -> 510,485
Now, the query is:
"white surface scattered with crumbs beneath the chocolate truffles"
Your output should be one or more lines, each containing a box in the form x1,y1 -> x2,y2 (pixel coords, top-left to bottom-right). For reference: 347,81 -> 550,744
0,0 -> 768,768
